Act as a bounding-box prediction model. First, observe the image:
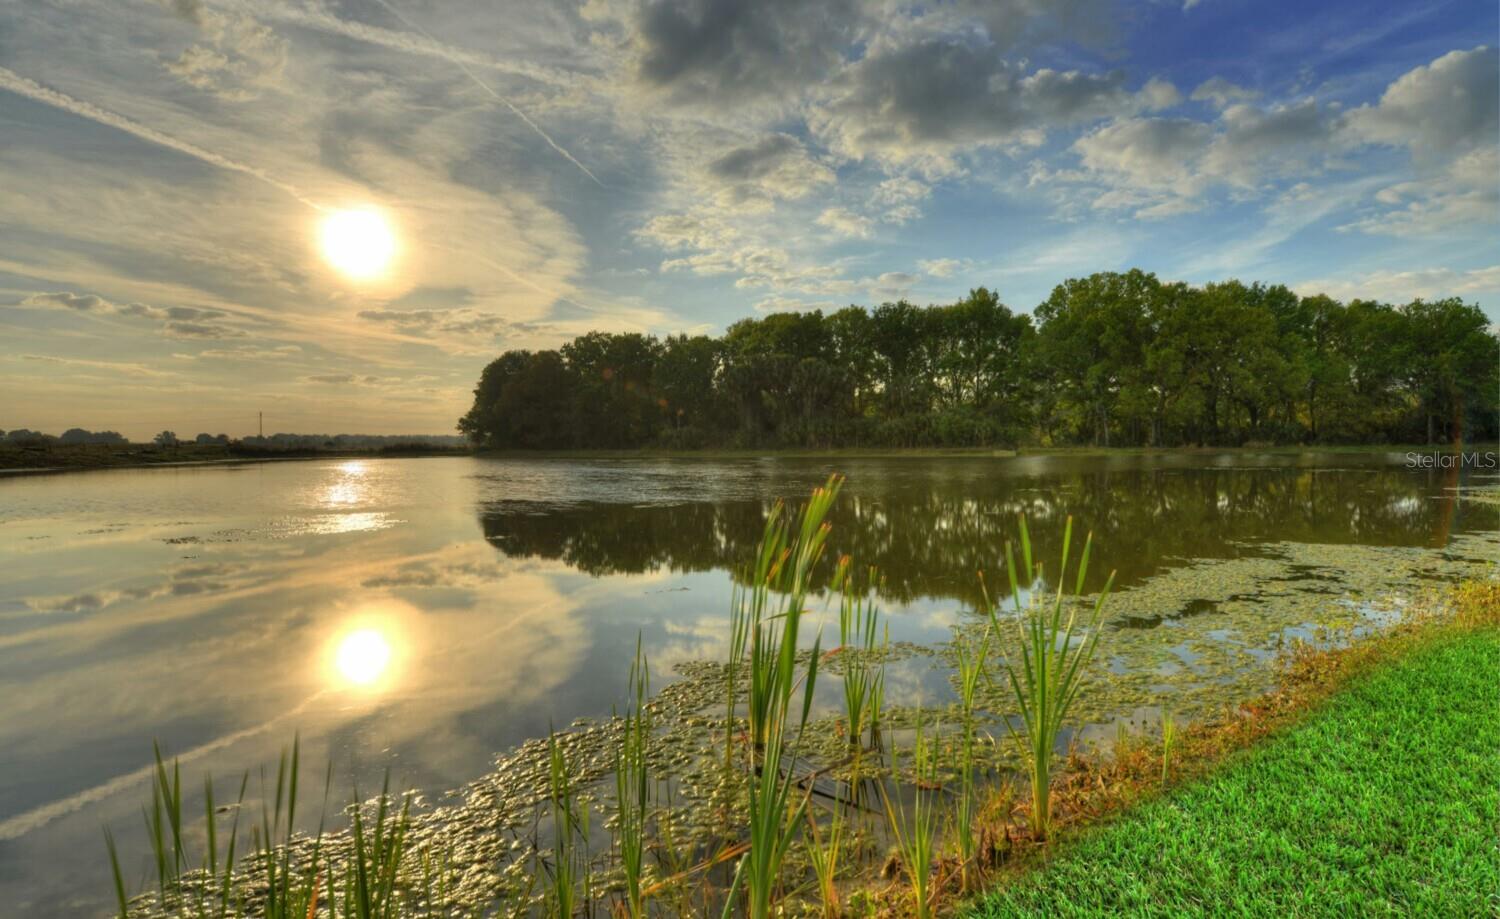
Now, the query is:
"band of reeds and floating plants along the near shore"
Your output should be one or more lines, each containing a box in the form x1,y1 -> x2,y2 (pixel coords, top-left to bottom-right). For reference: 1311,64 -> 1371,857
96,478 -> 1500,919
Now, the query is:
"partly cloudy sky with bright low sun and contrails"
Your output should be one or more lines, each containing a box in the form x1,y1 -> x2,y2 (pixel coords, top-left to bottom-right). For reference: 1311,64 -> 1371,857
0,0 -> 1500,439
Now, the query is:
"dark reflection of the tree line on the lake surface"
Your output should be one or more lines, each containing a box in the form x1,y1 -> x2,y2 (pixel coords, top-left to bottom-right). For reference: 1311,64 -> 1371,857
480,457 -> 1496,603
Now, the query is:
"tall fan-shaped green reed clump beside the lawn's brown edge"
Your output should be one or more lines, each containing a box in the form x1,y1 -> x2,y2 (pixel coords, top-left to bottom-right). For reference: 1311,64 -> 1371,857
981,516 -> 1115,840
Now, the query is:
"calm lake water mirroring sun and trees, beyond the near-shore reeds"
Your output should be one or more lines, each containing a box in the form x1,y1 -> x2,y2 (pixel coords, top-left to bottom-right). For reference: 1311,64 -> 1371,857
0,453 -> 1500,916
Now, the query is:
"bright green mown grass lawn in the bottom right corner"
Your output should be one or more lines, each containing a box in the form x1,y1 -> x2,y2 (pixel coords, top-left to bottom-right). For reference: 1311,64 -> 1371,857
972,630 -> 1500,919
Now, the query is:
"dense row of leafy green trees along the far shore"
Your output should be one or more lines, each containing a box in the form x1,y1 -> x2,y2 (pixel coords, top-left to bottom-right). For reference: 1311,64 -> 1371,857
459,270 -> 1500,450
